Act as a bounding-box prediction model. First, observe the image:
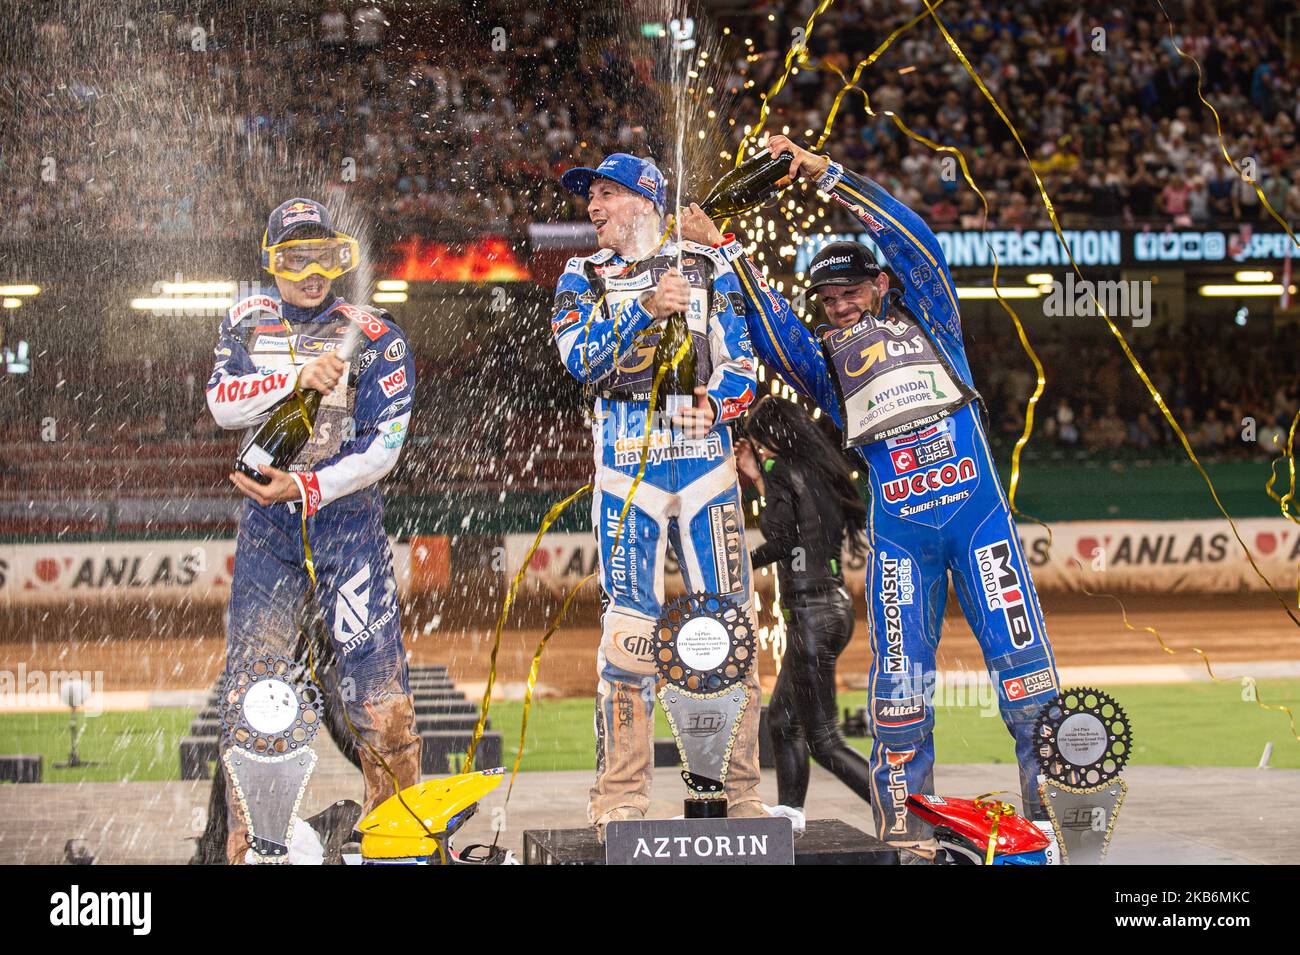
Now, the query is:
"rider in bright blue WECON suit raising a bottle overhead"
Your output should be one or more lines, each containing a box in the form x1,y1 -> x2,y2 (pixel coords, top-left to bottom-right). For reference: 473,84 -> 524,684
683,136 -> 1057,858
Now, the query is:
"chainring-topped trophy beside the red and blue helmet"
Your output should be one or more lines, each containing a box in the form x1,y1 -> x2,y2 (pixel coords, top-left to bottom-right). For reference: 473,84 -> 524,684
1034,687 -> 1132,865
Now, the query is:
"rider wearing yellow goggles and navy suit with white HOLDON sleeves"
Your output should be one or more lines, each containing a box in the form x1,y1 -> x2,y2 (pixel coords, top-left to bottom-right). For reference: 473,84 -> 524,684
207,199 -> 420,863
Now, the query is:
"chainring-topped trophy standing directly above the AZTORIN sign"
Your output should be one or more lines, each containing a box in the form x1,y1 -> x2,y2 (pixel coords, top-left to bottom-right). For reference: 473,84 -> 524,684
654,594 -> 754,819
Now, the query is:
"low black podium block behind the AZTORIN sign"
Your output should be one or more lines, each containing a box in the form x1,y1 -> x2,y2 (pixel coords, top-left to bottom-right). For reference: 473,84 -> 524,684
524,819 -> 898,865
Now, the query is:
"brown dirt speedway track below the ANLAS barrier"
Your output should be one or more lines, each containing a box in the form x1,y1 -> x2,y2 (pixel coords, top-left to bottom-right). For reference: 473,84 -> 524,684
0,594 -> 1300,696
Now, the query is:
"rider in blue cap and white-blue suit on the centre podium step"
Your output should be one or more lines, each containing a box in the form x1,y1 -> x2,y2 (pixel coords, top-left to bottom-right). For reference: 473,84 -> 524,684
551,153 -> 766,834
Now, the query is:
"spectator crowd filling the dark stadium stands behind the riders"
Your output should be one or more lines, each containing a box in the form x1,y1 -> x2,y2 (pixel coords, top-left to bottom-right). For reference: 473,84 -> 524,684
0,0 -> 1300,478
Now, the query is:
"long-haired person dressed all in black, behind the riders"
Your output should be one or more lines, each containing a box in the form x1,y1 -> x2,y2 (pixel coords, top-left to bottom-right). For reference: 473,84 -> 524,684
736,395 -> 871,812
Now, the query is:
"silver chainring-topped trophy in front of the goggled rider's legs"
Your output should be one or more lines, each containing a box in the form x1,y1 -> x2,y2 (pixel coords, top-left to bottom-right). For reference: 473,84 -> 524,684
221,656 -> 321,863
